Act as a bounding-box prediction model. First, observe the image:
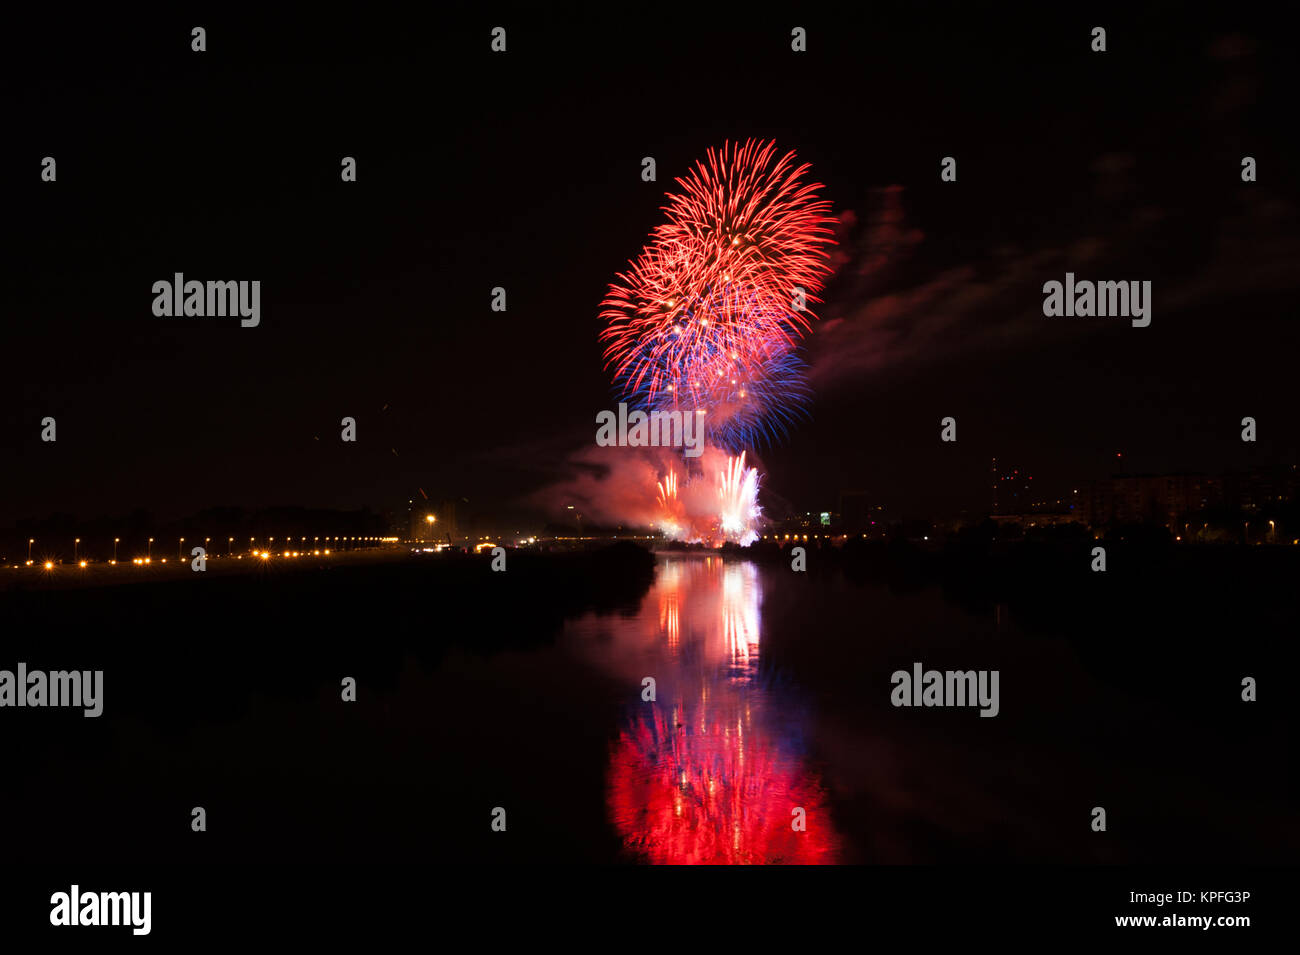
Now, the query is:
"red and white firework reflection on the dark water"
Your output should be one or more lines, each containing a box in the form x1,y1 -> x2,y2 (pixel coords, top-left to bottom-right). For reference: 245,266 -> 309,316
608,560 -> 837,864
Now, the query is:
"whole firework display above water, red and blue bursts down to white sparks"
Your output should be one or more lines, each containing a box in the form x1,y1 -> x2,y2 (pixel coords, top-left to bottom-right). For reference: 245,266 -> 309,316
601,140 -> 835,543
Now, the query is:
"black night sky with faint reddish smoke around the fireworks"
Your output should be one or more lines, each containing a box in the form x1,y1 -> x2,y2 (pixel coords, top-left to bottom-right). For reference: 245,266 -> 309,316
0,4 -> 1300,526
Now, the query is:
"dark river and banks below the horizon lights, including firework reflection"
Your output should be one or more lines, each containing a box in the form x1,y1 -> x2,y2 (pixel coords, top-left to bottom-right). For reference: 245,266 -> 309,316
0,548 -> 1300,865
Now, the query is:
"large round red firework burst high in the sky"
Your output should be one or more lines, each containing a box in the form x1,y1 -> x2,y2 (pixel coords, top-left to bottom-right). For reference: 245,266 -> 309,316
601,140 -> 835,407
